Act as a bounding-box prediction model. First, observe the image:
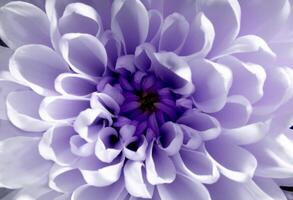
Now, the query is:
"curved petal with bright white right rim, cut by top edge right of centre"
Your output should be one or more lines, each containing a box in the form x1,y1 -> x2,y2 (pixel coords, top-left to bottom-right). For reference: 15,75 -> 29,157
199,0 -> 241,55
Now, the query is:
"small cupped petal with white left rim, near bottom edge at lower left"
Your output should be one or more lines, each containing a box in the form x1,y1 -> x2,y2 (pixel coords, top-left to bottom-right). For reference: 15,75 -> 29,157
49,165 -> 85,193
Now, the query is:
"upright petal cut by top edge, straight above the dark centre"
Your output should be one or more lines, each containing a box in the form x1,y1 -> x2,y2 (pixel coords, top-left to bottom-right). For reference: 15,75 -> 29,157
111,0 -> 149,54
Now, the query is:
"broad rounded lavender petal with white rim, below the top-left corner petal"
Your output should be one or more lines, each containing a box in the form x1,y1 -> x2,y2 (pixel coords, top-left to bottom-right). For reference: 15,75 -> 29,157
9,45 -> 68,96
